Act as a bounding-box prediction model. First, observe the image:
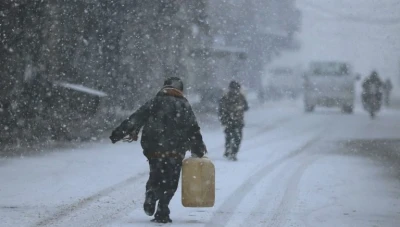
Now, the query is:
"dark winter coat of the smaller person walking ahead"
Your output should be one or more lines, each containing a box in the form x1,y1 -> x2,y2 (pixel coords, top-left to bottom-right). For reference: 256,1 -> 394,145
218,89 -> 249,127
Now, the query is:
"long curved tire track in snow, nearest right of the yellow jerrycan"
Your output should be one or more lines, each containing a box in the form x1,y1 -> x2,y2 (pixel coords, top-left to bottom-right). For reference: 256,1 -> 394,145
205,133 -> 323,227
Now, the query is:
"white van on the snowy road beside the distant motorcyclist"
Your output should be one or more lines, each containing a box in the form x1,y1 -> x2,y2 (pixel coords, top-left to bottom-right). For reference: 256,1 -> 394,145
304,62 -> 357,113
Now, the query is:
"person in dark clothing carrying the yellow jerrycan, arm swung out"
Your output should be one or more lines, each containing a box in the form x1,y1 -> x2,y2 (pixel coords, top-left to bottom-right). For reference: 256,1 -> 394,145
110,77 -> 207,223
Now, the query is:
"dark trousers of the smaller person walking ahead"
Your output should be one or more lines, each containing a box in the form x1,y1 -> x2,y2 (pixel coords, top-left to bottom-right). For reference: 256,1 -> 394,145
225,126 -> 243,156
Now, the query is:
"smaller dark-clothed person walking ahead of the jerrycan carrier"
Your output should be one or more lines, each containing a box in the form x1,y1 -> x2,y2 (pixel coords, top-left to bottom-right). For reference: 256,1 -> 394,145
218,81 -> 249,161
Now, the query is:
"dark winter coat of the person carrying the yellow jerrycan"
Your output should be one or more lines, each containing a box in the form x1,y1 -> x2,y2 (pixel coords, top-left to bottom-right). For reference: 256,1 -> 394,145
110,87 -> 205,157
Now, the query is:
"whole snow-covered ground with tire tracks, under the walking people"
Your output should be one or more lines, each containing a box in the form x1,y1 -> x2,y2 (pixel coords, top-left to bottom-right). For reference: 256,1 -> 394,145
0,98 -> 400,227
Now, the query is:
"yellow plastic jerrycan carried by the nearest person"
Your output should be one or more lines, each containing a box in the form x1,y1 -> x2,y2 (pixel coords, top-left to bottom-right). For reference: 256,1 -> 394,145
182,157 -> 215,207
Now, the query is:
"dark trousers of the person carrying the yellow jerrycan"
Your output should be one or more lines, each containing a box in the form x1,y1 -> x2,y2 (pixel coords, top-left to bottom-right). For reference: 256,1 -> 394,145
146,157 -> 182,216
